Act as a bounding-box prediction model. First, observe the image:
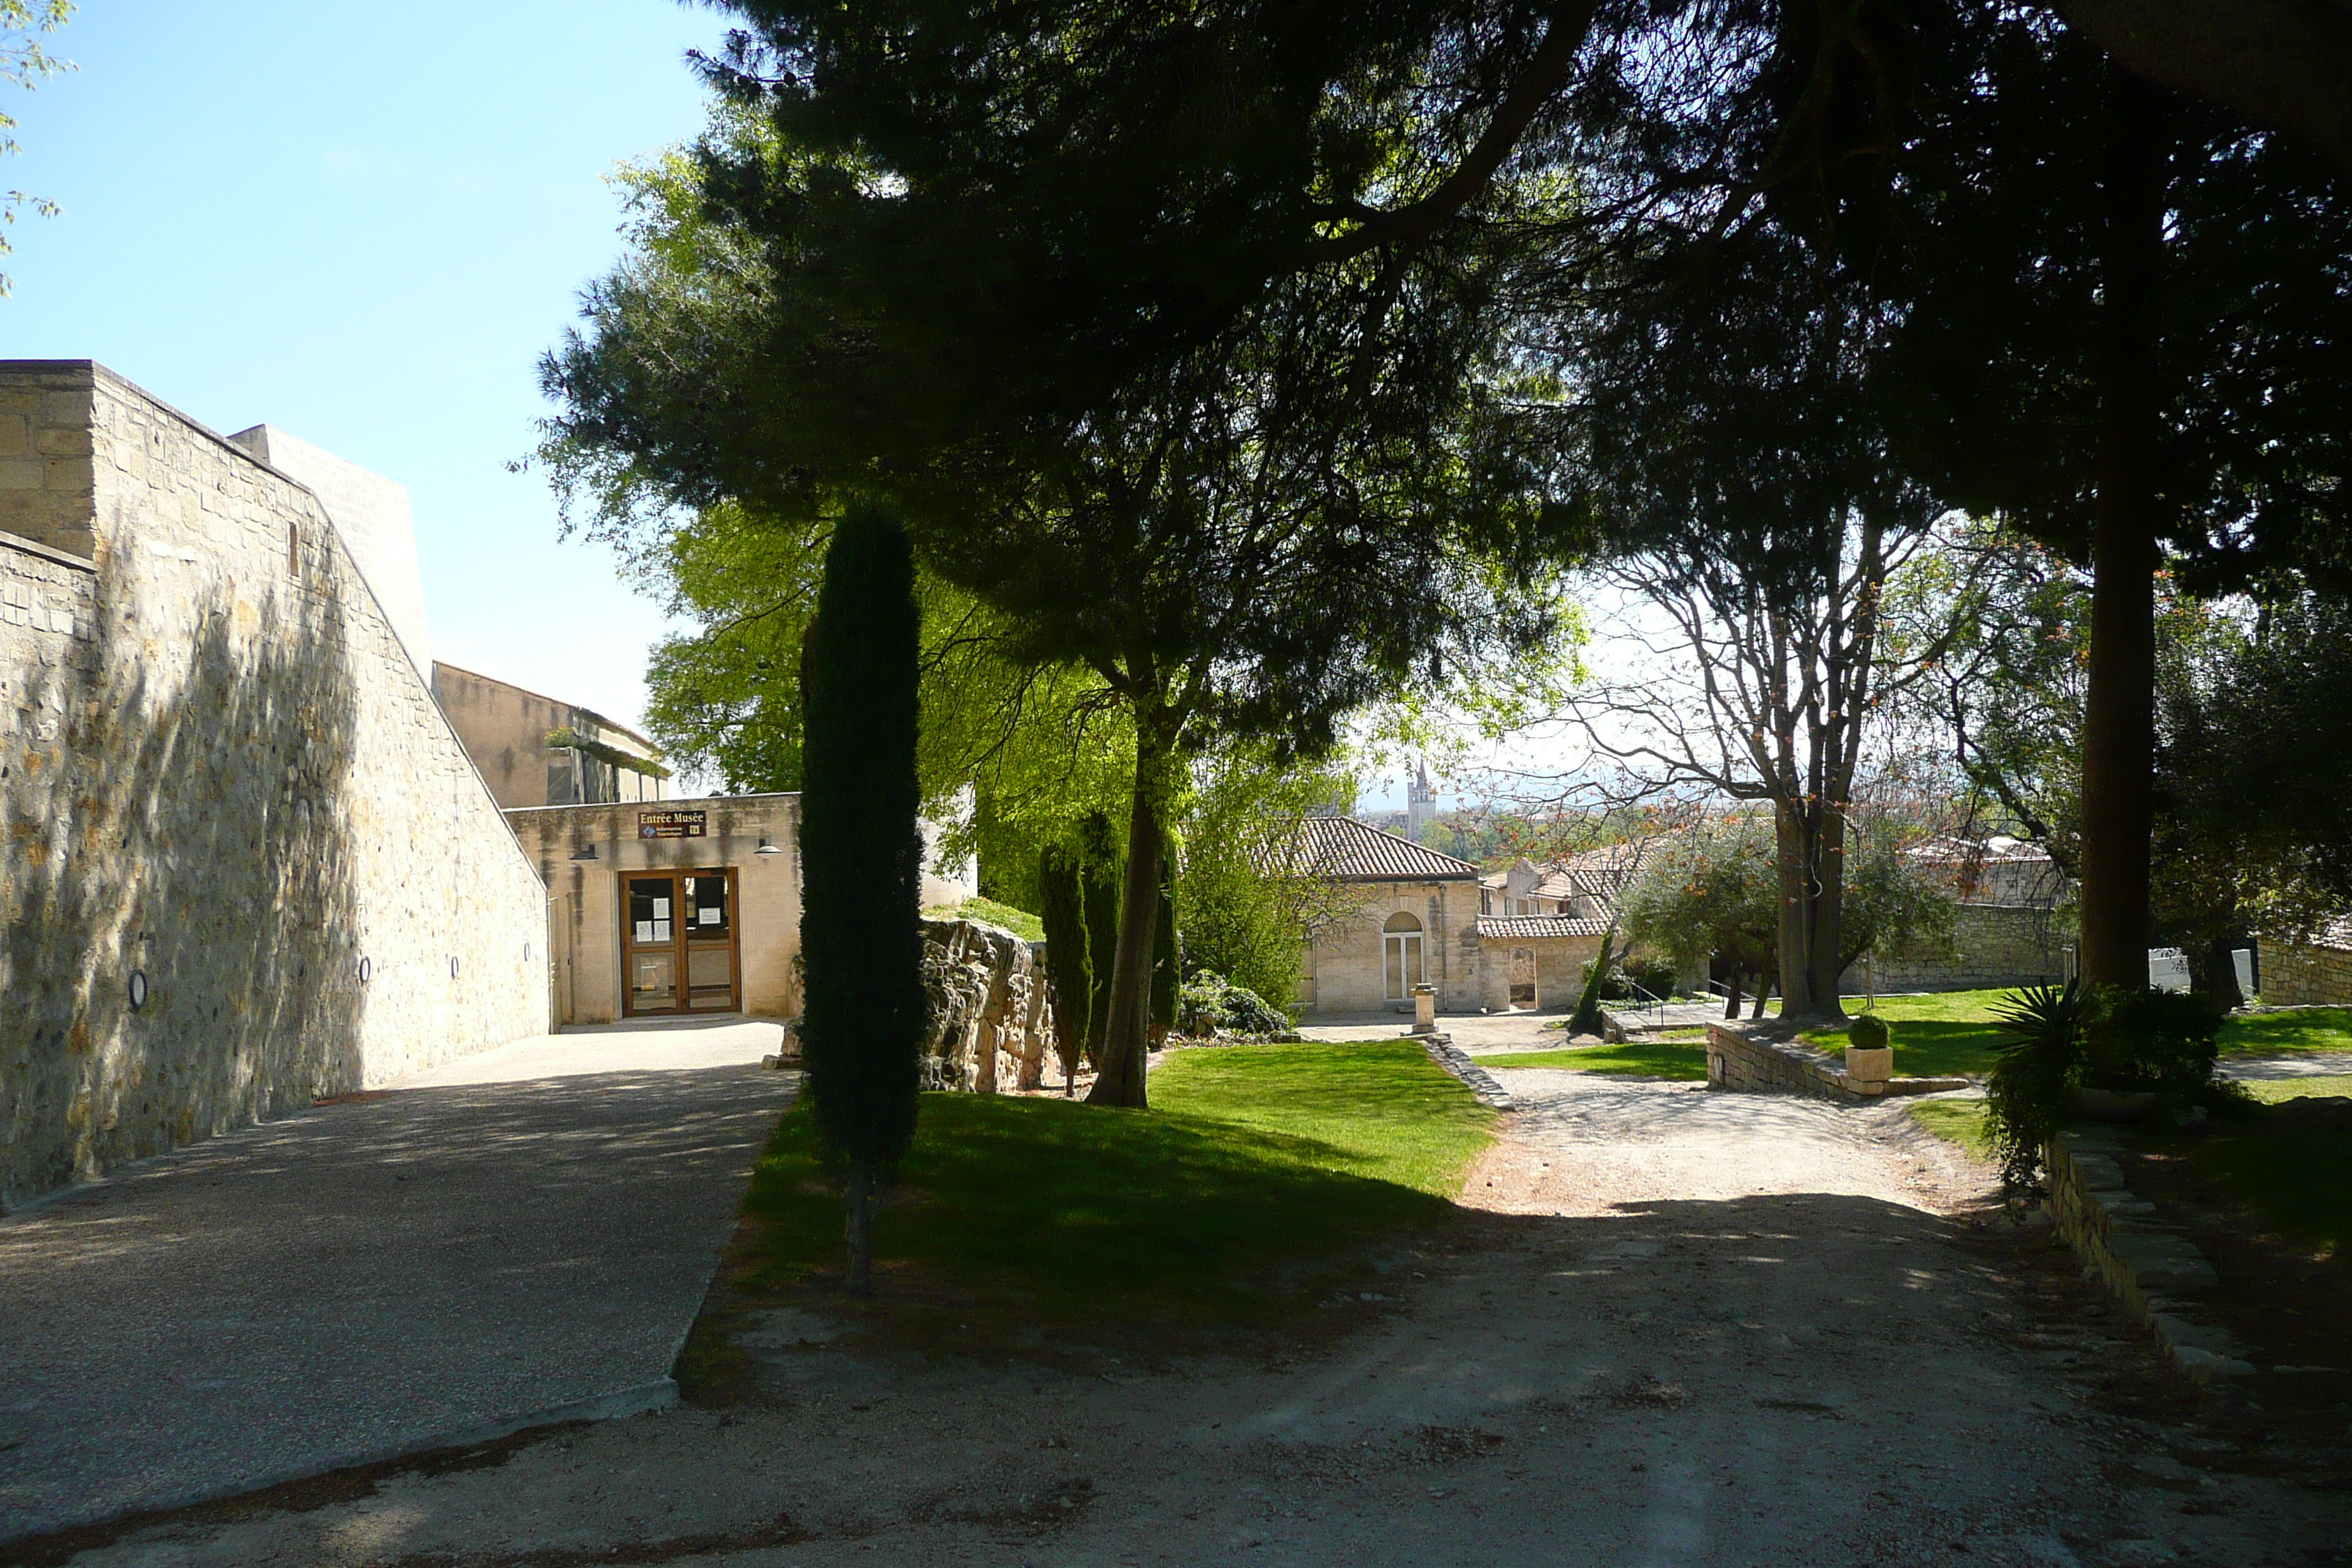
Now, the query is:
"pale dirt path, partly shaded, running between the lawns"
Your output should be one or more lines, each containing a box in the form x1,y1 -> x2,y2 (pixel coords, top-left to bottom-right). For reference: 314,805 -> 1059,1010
23,1070 -> 2352,1568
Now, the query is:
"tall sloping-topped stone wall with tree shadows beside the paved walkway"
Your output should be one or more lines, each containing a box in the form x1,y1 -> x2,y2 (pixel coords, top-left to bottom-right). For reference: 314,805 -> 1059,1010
0,362 -> 548,1204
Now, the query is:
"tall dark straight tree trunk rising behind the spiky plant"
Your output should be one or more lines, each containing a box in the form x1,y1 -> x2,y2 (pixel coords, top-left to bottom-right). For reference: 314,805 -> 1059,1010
2081,73 -> 2164,990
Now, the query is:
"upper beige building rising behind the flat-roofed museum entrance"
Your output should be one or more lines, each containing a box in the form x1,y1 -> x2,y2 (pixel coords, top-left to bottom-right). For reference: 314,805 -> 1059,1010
433,663 -> 671,811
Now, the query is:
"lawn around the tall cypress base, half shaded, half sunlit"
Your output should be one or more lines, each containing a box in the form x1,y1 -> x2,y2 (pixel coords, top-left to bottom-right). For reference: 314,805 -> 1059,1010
710,1041 -> 1493,1347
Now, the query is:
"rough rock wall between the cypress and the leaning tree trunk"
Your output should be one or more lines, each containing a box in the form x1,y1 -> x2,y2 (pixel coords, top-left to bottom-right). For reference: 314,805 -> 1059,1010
922,919 -> 1054,1096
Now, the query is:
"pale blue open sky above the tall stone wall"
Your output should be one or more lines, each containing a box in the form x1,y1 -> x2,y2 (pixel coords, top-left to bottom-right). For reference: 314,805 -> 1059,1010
0,0 -> 725,742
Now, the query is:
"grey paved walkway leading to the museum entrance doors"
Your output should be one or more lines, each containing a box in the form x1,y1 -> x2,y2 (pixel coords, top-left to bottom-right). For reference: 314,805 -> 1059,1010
0,1018 -> 797,1542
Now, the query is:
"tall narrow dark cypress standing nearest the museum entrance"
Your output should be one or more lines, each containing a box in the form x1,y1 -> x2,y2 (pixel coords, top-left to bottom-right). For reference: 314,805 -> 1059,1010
799,508 -> 929,1295
